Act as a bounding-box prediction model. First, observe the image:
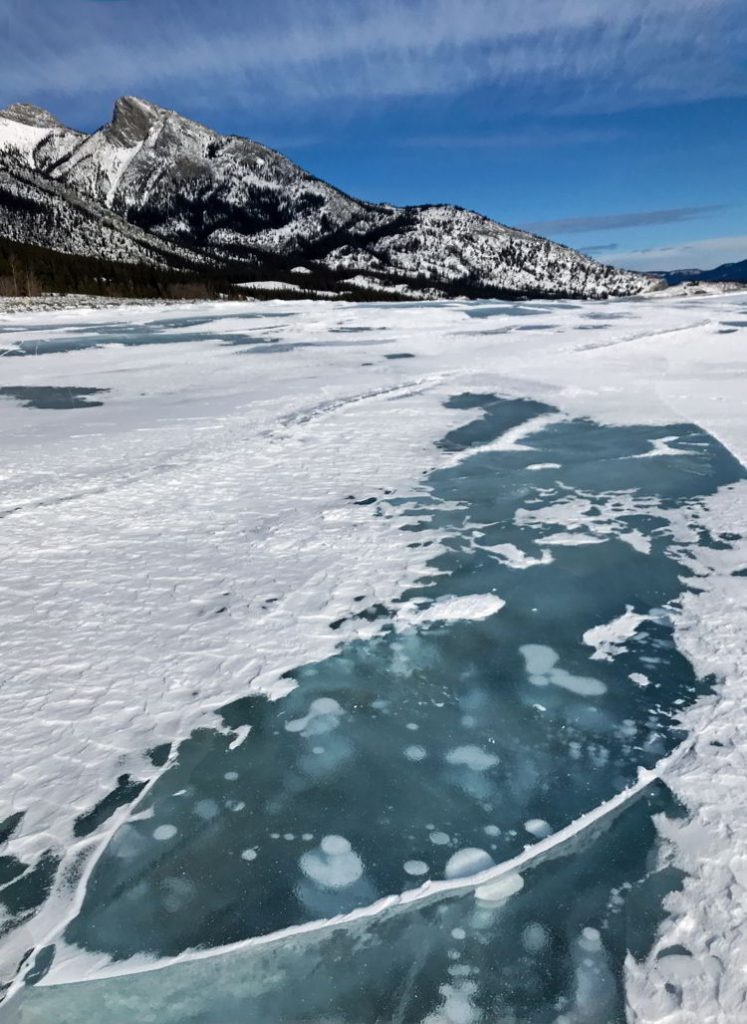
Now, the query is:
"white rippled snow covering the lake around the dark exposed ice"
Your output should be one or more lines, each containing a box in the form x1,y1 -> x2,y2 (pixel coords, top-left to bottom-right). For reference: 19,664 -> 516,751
0,293 -> 747,1024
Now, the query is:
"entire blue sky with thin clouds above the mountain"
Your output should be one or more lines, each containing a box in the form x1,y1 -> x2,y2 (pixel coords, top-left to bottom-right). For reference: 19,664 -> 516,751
0,0 -> 747,269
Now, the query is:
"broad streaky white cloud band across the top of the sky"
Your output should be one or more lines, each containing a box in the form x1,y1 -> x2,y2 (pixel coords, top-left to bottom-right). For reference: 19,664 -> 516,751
0,0 -> 747,118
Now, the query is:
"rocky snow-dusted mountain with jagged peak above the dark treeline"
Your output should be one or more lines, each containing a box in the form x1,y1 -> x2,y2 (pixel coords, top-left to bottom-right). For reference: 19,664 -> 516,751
0,96 -> 656,298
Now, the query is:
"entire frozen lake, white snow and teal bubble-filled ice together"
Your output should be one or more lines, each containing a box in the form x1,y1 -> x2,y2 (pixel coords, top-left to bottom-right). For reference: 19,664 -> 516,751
0,293 -> 747,1024
